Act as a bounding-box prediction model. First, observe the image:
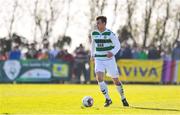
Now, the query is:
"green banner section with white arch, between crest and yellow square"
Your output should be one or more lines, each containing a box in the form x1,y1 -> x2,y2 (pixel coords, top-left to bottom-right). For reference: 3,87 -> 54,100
16,60 -> 52,82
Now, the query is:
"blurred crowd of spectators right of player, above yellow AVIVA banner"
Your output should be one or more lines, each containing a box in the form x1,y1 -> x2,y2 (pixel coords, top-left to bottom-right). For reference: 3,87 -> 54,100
116,42 -> 180,60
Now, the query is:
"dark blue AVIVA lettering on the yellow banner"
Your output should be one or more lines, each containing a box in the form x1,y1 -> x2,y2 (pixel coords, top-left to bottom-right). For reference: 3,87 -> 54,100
118,66 -> 158,77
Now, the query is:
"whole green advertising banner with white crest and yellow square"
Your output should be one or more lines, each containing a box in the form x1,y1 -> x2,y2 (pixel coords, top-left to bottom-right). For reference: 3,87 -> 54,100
0,60 -> 71,83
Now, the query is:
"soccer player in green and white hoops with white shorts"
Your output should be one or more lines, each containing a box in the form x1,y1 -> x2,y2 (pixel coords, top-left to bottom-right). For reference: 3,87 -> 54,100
91,16 -> 129,107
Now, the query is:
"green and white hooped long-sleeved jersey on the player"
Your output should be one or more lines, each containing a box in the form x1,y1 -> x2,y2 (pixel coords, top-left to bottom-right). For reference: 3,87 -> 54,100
91,29 -> 120,60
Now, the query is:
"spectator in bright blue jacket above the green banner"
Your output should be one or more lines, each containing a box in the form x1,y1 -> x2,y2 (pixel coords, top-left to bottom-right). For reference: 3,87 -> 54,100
9,46 -> 21,60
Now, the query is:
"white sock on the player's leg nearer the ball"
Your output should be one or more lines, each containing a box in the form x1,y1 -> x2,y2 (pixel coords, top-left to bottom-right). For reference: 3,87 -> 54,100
98,81 -> 110,99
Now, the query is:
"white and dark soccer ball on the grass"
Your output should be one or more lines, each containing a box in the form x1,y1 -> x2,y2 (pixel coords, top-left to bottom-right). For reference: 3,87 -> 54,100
82,96 -> 94,107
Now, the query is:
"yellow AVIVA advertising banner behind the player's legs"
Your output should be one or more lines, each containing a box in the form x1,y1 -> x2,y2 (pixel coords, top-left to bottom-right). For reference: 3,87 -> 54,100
91,60 -> 163,82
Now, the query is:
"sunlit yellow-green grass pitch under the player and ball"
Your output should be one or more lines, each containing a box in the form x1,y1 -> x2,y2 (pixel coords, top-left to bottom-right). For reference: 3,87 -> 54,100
0,84 -> 180,115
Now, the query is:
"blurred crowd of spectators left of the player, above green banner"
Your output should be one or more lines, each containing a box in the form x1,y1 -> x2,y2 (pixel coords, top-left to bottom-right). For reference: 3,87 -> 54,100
0,43 -> 90,83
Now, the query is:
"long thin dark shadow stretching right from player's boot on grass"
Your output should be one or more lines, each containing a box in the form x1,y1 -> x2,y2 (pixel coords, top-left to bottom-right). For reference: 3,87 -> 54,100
129,106 -> 180,111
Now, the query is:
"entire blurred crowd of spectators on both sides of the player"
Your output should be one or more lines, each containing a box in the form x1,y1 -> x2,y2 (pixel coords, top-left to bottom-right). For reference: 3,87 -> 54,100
0,42 -> 180,83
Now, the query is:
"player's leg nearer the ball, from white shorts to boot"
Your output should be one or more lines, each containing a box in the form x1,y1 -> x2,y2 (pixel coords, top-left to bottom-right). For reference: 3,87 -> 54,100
95,60 -> 112,107
